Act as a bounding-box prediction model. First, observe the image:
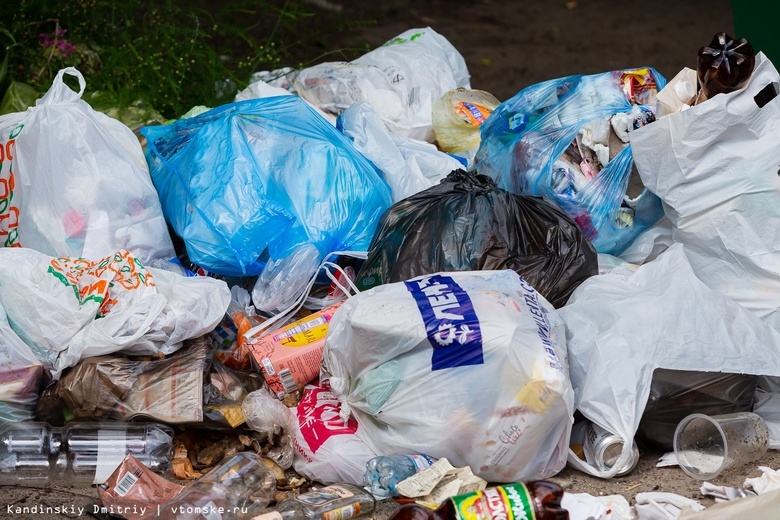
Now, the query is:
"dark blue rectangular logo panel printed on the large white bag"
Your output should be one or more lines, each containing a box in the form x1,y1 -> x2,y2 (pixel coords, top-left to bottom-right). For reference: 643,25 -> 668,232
404,275 -> 484,370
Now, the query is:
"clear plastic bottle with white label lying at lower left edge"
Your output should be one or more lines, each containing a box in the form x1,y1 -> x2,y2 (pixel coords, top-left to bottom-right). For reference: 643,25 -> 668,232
0,422 -> 173,485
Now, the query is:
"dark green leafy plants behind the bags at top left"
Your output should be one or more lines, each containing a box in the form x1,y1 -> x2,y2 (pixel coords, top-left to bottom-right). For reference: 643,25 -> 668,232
0,0 -> 372,118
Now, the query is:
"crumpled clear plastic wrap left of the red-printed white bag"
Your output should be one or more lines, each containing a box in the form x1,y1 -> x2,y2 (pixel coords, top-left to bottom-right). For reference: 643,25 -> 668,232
241,388 -> 298,469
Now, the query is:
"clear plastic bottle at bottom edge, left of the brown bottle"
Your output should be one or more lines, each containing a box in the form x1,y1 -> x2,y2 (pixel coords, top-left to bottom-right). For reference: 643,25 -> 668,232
254,483 -> 376,520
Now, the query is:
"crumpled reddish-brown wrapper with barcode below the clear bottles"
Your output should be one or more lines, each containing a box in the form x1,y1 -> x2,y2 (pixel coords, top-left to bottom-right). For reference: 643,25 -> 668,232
98,455 -> 184,520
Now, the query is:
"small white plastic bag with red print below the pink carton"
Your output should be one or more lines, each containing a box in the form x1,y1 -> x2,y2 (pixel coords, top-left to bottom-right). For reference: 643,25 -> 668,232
293,385 -> 376,486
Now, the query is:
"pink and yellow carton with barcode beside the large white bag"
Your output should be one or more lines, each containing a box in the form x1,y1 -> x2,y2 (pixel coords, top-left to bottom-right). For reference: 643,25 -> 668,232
246,302 -> 343,399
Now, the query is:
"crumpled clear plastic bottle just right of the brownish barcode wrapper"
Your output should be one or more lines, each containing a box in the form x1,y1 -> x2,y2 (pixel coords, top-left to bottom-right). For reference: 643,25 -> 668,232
158,451 -> 276,520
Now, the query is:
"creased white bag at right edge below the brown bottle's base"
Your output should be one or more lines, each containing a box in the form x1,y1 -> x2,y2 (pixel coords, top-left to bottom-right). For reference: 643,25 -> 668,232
631,53 -> 780,330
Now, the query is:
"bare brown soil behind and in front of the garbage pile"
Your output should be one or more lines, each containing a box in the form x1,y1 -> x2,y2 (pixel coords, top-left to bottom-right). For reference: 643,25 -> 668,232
0,0 -> 780,520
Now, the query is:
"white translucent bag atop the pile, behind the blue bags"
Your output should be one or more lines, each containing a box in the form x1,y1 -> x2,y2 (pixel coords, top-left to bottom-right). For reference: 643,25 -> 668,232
293,27 -> 470,142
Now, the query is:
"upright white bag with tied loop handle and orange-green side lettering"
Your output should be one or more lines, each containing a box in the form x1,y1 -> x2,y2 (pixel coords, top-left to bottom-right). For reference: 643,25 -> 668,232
0,67 -> 176,262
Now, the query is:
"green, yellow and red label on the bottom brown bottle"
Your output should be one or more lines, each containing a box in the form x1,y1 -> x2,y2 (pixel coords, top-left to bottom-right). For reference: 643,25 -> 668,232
451,483 -> 536,520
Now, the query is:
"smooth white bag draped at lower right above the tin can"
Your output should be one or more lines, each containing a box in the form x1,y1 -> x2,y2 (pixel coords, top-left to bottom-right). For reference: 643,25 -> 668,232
558,244 -> 780,477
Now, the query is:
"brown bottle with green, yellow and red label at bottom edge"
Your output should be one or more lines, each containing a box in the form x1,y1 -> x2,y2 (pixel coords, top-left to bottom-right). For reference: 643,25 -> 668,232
390,480 -> 569,520
